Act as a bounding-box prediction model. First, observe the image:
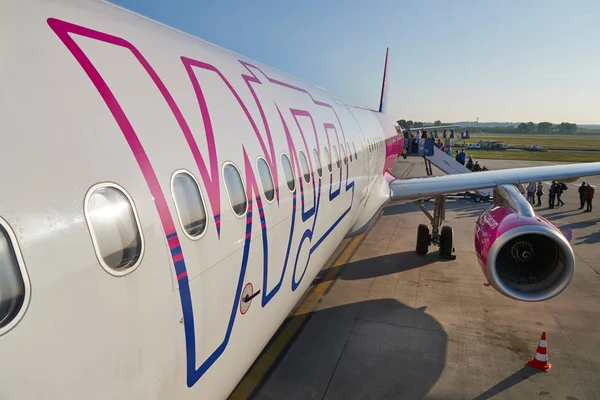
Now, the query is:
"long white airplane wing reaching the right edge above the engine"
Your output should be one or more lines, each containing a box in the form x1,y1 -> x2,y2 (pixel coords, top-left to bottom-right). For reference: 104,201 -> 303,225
390,162 -> 600,201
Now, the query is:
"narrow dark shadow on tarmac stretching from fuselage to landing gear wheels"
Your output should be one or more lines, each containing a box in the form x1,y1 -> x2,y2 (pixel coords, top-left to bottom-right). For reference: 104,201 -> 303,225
315,250 -> 451,283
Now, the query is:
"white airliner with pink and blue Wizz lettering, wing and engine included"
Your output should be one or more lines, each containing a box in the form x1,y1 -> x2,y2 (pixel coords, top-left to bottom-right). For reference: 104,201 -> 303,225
0,0 -> 600,400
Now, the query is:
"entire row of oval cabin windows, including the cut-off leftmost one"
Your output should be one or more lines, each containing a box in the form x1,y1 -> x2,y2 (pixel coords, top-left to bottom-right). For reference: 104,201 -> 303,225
0,139 -> 358,335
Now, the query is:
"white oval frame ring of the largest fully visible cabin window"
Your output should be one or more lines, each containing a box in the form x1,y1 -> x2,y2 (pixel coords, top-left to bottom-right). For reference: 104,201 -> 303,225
83,181 -> 146,277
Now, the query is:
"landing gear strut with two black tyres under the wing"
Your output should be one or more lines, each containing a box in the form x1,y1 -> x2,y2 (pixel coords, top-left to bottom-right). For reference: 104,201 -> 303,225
415,196 -> 456,260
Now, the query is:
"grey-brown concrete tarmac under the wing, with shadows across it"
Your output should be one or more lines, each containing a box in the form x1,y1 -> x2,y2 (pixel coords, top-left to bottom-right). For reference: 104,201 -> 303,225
231,158 -> 600,400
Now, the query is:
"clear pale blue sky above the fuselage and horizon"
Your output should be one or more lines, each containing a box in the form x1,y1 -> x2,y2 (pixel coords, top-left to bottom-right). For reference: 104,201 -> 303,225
113,0 -> 600,124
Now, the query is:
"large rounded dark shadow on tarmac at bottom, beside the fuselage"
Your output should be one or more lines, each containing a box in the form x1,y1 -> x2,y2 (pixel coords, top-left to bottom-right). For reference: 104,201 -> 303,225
251,299 -> 448,400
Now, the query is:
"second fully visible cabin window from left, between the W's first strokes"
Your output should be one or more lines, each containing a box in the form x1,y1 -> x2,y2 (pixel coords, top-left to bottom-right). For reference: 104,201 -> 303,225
171,171 -> 206,239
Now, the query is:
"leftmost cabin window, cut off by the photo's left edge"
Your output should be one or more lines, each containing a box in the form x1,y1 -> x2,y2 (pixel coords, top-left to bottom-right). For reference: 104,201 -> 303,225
0,220 -> 29,334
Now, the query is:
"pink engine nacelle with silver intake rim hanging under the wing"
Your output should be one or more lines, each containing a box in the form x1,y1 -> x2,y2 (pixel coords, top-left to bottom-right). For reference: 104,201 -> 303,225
475,185 -> 575,301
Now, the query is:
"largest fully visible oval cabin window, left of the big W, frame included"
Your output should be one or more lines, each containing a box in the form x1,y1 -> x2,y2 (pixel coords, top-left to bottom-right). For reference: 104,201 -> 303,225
85,184 -> 144,276
